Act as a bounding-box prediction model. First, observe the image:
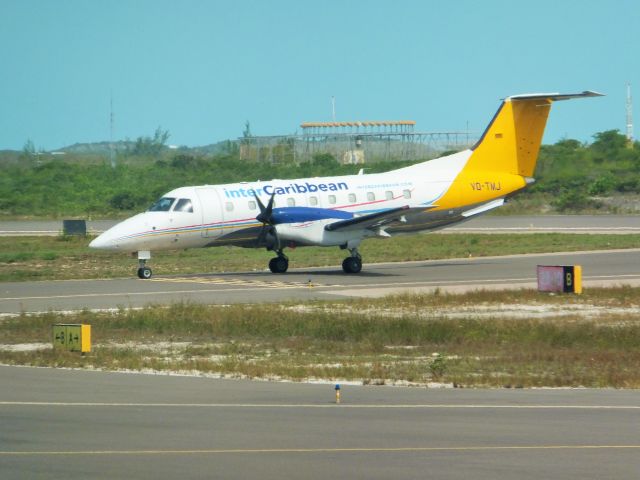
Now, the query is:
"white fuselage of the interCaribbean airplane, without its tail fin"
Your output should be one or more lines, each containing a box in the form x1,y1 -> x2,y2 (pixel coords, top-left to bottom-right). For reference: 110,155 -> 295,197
93,150 -> 526,251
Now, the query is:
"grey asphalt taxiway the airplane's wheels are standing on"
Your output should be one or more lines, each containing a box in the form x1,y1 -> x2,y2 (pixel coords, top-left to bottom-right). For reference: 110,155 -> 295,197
0,249 -> 640,314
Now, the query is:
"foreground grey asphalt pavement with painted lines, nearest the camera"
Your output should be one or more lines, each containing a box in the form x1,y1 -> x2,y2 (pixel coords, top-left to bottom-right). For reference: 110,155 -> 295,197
0,367 -> 640,480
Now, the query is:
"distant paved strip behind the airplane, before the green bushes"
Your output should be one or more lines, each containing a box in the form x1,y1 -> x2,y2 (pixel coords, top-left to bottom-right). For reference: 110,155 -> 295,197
0,215 -> 640,236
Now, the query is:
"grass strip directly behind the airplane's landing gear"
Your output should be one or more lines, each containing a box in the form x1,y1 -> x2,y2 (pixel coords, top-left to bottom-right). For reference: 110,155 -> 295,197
0,233 -> 640,282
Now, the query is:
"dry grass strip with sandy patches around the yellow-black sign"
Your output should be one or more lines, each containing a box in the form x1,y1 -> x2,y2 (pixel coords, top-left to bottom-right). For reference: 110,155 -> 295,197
0,287 -> 640,388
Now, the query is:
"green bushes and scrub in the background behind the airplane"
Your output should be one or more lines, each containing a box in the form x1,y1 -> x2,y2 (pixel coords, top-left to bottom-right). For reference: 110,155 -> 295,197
0,130 -> 640,218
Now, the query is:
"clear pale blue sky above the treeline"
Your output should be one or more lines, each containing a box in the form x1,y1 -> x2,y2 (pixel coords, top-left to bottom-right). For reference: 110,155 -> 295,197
0,0 -> 640,150
